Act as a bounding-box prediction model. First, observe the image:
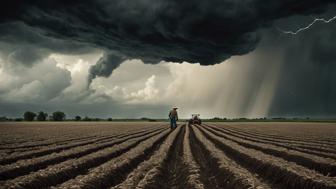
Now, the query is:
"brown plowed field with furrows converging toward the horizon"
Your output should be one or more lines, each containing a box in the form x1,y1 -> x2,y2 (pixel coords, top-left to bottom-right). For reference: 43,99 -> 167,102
0,122 -> 336,189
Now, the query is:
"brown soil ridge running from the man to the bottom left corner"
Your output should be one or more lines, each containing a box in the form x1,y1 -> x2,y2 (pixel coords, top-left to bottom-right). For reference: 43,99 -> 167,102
3,129 -> 168,189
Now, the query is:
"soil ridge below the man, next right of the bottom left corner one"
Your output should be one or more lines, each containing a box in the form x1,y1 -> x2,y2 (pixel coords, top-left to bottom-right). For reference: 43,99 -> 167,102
55,130 -> 170,188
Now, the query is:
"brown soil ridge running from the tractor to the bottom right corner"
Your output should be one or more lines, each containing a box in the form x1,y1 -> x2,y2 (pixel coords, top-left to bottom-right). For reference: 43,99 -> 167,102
198,124 -> 336,189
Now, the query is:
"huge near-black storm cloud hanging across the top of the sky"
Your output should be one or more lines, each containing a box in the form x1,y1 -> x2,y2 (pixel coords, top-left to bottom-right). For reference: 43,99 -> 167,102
0,0 -> 334,77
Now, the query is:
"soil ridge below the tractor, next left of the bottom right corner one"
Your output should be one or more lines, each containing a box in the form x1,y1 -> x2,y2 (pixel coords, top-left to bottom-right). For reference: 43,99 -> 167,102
191,126 -> 276,189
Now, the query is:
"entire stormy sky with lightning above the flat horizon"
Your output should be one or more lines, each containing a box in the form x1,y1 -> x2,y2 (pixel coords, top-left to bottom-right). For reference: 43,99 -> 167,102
0,0 -> 336,118
